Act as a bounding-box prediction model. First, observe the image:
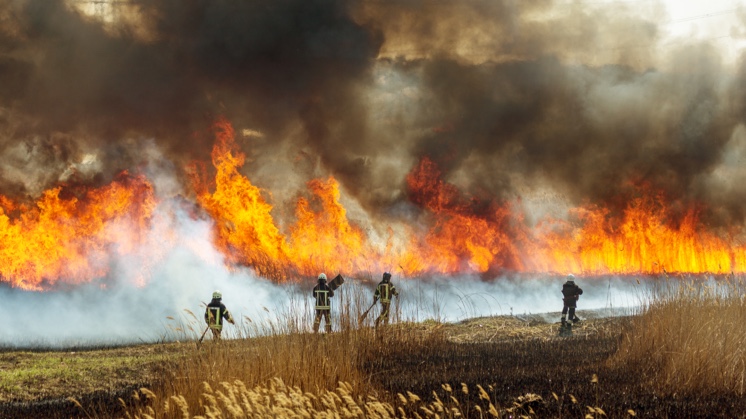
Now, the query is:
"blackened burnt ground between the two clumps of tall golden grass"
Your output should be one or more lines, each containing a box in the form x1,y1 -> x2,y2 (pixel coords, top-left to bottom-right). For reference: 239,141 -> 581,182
365,319 -> 746,418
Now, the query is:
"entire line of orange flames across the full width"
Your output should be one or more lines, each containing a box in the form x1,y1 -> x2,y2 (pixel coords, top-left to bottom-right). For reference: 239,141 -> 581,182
0,119 -> 746,290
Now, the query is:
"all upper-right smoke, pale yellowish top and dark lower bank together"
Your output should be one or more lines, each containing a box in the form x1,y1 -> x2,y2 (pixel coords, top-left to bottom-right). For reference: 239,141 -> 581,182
352,1 -> 744,230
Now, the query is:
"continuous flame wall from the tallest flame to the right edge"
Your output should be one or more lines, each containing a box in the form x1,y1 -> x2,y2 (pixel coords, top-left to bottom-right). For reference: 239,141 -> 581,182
190,121 -> 746,280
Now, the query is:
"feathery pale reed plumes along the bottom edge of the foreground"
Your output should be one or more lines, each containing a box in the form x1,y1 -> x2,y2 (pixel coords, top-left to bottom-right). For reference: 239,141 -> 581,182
126,378 -> 548,419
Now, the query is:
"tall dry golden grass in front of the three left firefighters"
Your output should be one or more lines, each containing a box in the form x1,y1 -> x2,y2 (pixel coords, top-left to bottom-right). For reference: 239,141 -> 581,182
116,285 -> 535,418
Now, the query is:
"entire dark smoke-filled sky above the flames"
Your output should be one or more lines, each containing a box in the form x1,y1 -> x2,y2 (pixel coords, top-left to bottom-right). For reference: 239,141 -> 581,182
0,0 -> 746,228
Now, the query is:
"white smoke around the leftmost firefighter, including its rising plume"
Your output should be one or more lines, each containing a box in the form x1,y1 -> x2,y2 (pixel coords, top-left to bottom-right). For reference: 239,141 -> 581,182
0,199 -> 286,348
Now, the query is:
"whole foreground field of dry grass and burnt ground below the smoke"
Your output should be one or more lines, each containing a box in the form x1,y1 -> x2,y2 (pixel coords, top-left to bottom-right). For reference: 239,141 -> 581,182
0,280 -> 746,418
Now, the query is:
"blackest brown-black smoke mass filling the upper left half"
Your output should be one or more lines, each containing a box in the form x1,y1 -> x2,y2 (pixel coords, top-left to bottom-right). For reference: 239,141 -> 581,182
0,0 -> 380,199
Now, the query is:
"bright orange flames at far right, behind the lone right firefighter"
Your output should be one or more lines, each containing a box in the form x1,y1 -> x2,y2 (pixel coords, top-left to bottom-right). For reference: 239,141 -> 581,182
531,193 -> 746,274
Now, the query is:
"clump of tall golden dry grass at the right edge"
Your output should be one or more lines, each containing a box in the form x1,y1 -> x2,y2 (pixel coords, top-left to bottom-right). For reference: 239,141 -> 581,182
611,277 -> 746,396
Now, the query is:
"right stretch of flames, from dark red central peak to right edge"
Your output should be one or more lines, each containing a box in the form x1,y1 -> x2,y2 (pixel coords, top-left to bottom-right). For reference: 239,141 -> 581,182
407,158 -> 746,274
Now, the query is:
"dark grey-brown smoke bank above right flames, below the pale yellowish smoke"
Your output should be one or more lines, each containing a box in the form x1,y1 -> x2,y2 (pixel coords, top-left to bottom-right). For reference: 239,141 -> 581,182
406,47 -> 737,213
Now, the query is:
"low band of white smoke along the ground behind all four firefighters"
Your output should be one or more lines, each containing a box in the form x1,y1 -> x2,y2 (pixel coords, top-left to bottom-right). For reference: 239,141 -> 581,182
0,272 -> 641,349
